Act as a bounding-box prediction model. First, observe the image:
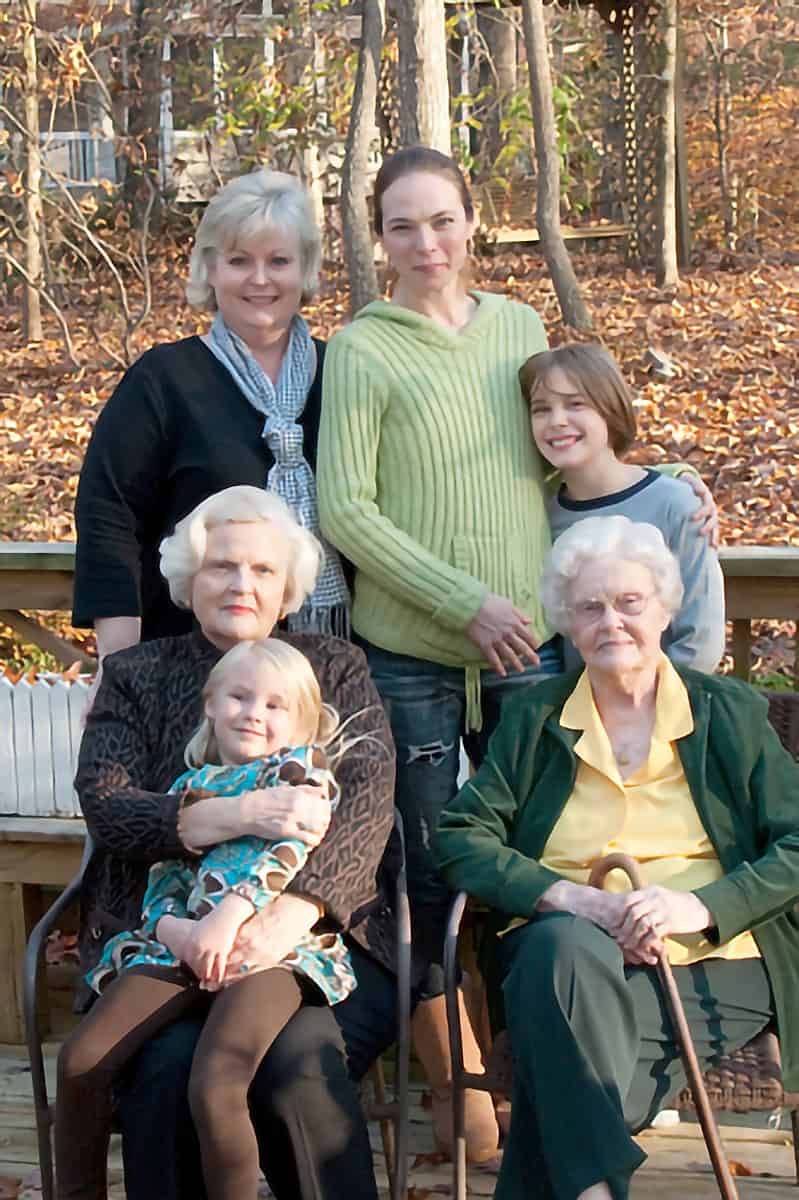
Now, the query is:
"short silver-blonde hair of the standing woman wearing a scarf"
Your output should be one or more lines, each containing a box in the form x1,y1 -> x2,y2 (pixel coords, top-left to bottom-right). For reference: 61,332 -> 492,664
186,167 -> 322,312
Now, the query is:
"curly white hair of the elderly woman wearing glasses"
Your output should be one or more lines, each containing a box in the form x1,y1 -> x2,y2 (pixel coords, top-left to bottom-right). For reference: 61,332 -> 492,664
541,516 -> 683,634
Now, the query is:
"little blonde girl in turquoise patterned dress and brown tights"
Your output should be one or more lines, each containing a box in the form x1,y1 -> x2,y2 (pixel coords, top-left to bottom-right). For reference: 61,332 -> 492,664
55,638 -> 355,1200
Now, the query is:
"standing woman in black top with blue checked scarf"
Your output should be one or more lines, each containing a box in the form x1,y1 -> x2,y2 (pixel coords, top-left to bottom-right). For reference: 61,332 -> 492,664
73,169 -> 349,696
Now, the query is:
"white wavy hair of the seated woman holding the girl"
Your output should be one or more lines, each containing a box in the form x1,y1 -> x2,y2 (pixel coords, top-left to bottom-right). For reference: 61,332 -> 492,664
160,484 -> 324,617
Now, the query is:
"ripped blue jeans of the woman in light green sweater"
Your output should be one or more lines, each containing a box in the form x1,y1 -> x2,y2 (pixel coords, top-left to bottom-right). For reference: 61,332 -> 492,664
360,637 -> 563,998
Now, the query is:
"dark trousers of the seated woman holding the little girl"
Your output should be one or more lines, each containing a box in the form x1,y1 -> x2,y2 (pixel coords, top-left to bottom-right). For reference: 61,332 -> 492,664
116,943 -> 397,1200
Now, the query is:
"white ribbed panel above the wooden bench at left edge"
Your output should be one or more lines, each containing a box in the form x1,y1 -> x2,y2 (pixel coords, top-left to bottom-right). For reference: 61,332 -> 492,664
0,677 -> 89,817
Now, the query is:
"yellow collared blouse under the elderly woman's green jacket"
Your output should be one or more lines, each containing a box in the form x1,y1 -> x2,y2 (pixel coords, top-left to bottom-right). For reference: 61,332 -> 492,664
541,654 -> 759,966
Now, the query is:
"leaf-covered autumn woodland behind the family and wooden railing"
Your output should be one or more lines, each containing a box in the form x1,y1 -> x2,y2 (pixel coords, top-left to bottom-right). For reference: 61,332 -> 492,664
0,0 -> 799,679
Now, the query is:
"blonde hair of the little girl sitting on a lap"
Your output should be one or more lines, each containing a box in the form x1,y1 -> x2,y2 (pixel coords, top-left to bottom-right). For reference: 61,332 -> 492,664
184,637 -> 338,769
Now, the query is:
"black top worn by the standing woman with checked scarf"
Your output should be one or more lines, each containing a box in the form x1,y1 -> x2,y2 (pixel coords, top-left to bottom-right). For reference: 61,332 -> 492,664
72,337 -> 333,641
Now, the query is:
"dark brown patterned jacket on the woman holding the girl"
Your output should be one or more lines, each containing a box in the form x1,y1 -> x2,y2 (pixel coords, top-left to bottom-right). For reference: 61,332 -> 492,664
76,632 -> 400,1001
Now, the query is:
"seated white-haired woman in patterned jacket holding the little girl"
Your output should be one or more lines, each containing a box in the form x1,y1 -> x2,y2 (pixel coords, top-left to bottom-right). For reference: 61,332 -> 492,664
70,486 -> 397,1200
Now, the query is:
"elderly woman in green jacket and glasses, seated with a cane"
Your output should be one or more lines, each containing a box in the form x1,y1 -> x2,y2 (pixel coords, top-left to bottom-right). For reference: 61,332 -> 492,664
437,517 -> 799,1200
